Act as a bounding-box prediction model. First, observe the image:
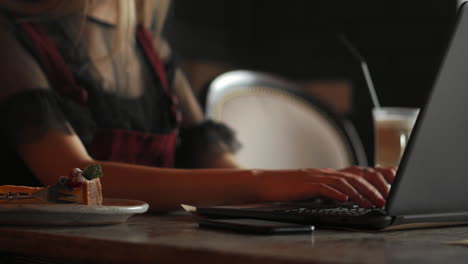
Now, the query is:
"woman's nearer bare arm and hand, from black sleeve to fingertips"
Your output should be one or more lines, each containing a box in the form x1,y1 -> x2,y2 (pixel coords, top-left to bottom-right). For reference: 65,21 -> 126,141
19,130 -> 392,211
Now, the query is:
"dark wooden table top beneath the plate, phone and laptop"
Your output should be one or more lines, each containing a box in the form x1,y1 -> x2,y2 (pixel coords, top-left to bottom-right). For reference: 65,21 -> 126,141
0,213 -> 468,264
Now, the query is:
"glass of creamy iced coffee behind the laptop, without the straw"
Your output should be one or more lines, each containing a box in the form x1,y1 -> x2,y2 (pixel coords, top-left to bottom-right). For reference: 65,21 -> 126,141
372,107 -> 419,167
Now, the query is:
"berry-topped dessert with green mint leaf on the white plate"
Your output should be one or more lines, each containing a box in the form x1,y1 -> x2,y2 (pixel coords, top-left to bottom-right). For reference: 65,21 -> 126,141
0,165 -> 102,205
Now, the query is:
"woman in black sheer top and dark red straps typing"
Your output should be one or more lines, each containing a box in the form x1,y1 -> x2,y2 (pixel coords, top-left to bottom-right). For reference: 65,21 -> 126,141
0,0 -> 395,211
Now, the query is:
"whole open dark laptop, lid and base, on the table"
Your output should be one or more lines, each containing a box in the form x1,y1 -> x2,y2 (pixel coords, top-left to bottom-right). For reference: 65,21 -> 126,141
197,3 -> 468,230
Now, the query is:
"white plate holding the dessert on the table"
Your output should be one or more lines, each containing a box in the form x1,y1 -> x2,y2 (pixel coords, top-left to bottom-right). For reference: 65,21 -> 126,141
0,199 -> 149,225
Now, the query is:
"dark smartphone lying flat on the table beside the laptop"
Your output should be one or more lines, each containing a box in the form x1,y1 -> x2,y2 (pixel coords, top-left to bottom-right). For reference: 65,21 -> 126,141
198,219 -> 315,235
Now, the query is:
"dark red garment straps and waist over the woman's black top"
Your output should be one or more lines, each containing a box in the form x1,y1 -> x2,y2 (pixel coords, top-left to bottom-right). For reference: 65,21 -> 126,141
21,23 -> 181,168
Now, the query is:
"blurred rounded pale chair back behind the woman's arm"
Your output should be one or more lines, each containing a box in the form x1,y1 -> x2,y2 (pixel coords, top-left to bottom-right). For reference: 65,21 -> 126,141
205,70 -> 367,169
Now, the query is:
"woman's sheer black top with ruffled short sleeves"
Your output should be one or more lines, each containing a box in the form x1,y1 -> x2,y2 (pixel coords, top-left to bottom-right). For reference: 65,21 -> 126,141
0,13 -> 238,186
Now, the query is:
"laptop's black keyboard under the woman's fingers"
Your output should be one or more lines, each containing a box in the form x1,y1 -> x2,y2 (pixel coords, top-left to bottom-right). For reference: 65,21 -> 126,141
276,206 -> 386,217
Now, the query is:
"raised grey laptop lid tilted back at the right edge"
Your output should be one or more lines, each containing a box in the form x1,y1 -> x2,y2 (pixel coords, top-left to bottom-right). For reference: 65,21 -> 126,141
387,3 -> 468,215
